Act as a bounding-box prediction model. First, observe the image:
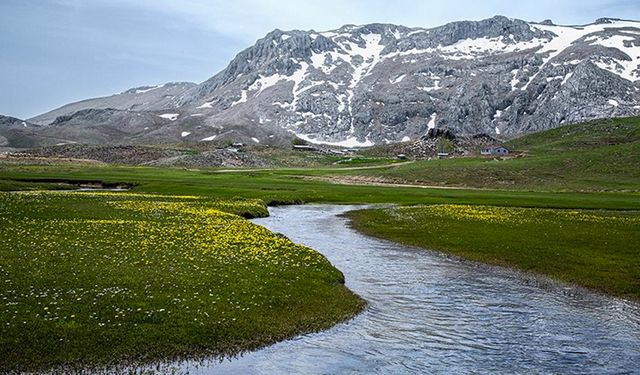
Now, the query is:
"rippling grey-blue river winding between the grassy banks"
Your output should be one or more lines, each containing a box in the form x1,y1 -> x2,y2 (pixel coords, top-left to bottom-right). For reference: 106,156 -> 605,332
189,205 -> 640,374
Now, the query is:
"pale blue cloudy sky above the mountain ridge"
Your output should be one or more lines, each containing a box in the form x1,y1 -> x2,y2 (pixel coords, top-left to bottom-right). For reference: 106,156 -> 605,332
0,0 -> 640,118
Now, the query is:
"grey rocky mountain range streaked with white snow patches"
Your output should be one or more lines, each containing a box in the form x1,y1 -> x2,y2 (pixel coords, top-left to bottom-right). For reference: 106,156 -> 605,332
16,16 -> 640,146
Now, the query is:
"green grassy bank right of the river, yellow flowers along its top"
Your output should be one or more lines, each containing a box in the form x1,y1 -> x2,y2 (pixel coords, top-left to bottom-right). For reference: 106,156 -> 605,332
348,205 -> 640,301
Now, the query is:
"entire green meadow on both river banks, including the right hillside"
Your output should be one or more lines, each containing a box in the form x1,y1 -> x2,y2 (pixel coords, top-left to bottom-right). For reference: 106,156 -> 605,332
0,118 -> 640,371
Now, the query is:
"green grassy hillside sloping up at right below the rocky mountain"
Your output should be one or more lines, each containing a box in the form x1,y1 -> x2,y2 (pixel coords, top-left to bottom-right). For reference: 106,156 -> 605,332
353,117 -> 640,191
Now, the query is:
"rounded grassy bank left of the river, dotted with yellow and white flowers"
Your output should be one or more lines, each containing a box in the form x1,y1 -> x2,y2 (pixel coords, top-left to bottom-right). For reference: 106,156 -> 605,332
0,192 -> 363,372
